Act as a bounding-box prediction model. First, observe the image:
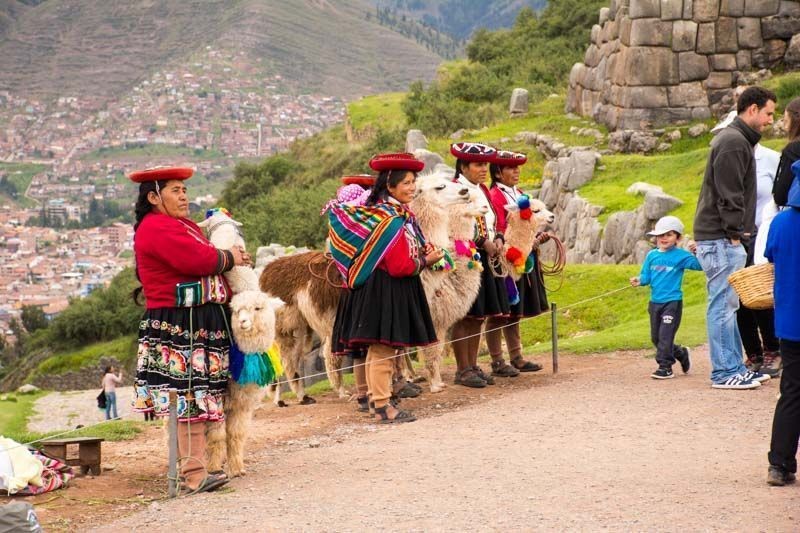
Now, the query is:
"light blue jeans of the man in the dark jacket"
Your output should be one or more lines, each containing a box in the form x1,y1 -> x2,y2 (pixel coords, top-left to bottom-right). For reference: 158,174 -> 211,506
697,239 -> 747,383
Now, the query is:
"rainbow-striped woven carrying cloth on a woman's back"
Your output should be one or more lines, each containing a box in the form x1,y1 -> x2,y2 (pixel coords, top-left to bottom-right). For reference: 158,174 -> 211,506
328,203 -> 411,289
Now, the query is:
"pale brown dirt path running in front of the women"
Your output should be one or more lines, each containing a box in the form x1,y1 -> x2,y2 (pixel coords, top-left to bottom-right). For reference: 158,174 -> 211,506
14,350 -> 800,532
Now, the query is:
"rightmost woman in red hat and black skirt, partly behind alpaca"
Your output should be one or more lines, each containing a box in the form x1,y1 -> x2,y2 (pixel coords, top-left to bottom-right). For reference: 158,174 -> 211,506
486,150 -> 549,377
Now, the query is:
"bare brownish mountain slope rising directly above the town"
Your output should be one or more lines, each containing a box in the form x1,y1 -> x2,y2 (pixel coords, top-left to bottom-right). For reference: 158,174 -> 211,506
0,0 -> 442,100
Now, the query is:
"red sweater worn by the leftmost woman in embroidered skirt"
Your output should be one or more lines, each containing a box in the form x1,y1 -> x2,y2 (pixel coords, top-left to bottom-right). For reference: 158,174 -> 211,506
134,212 -> 230,309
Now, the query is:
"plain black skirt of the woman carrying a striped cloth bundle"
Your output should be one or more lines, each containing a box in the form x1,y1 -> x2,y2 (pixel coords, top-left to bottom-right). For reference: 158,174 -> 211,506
333,268 -> 436,353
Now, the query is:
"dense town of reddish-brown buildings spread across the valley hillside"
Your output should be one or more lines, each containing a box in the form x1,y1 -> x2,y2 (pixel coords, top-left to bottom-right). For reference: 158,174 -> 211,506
0,47 -> 345,332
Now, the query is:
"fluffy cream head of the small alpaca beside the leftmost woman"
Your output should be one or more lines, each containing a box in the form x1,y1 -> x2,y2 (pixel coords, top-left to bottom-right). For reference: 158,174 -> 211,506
230,291 -> 284,352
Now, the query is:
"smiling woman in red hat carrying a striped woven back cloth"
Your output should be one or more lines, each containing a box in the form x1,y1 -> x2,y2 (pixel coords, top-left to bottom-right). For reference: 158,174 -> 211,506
329,153 -> 444,423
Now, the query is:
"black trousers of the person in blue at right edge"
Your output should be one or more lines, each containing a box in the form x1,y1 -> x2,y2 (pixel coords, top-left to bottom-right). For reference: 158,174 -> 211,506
767,339 -> 800,473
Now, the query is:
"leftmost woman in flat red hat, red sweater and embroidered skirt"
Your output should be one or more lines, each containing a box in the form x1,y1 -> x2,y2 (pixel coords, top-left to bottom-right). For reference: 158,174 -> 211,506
130,168 -> 250,491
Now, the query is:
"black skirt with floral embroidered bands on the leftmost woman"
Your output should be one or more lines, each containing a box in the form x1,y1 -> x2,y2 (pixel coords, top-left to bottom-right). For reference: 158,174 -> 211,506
133,304 -> 231,422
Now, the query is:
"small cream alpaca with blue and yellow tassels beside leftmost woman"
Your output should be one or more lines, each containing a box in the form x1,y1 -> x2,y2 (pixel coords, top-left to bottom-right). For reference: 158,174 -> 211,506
207,290 -> 283,477
